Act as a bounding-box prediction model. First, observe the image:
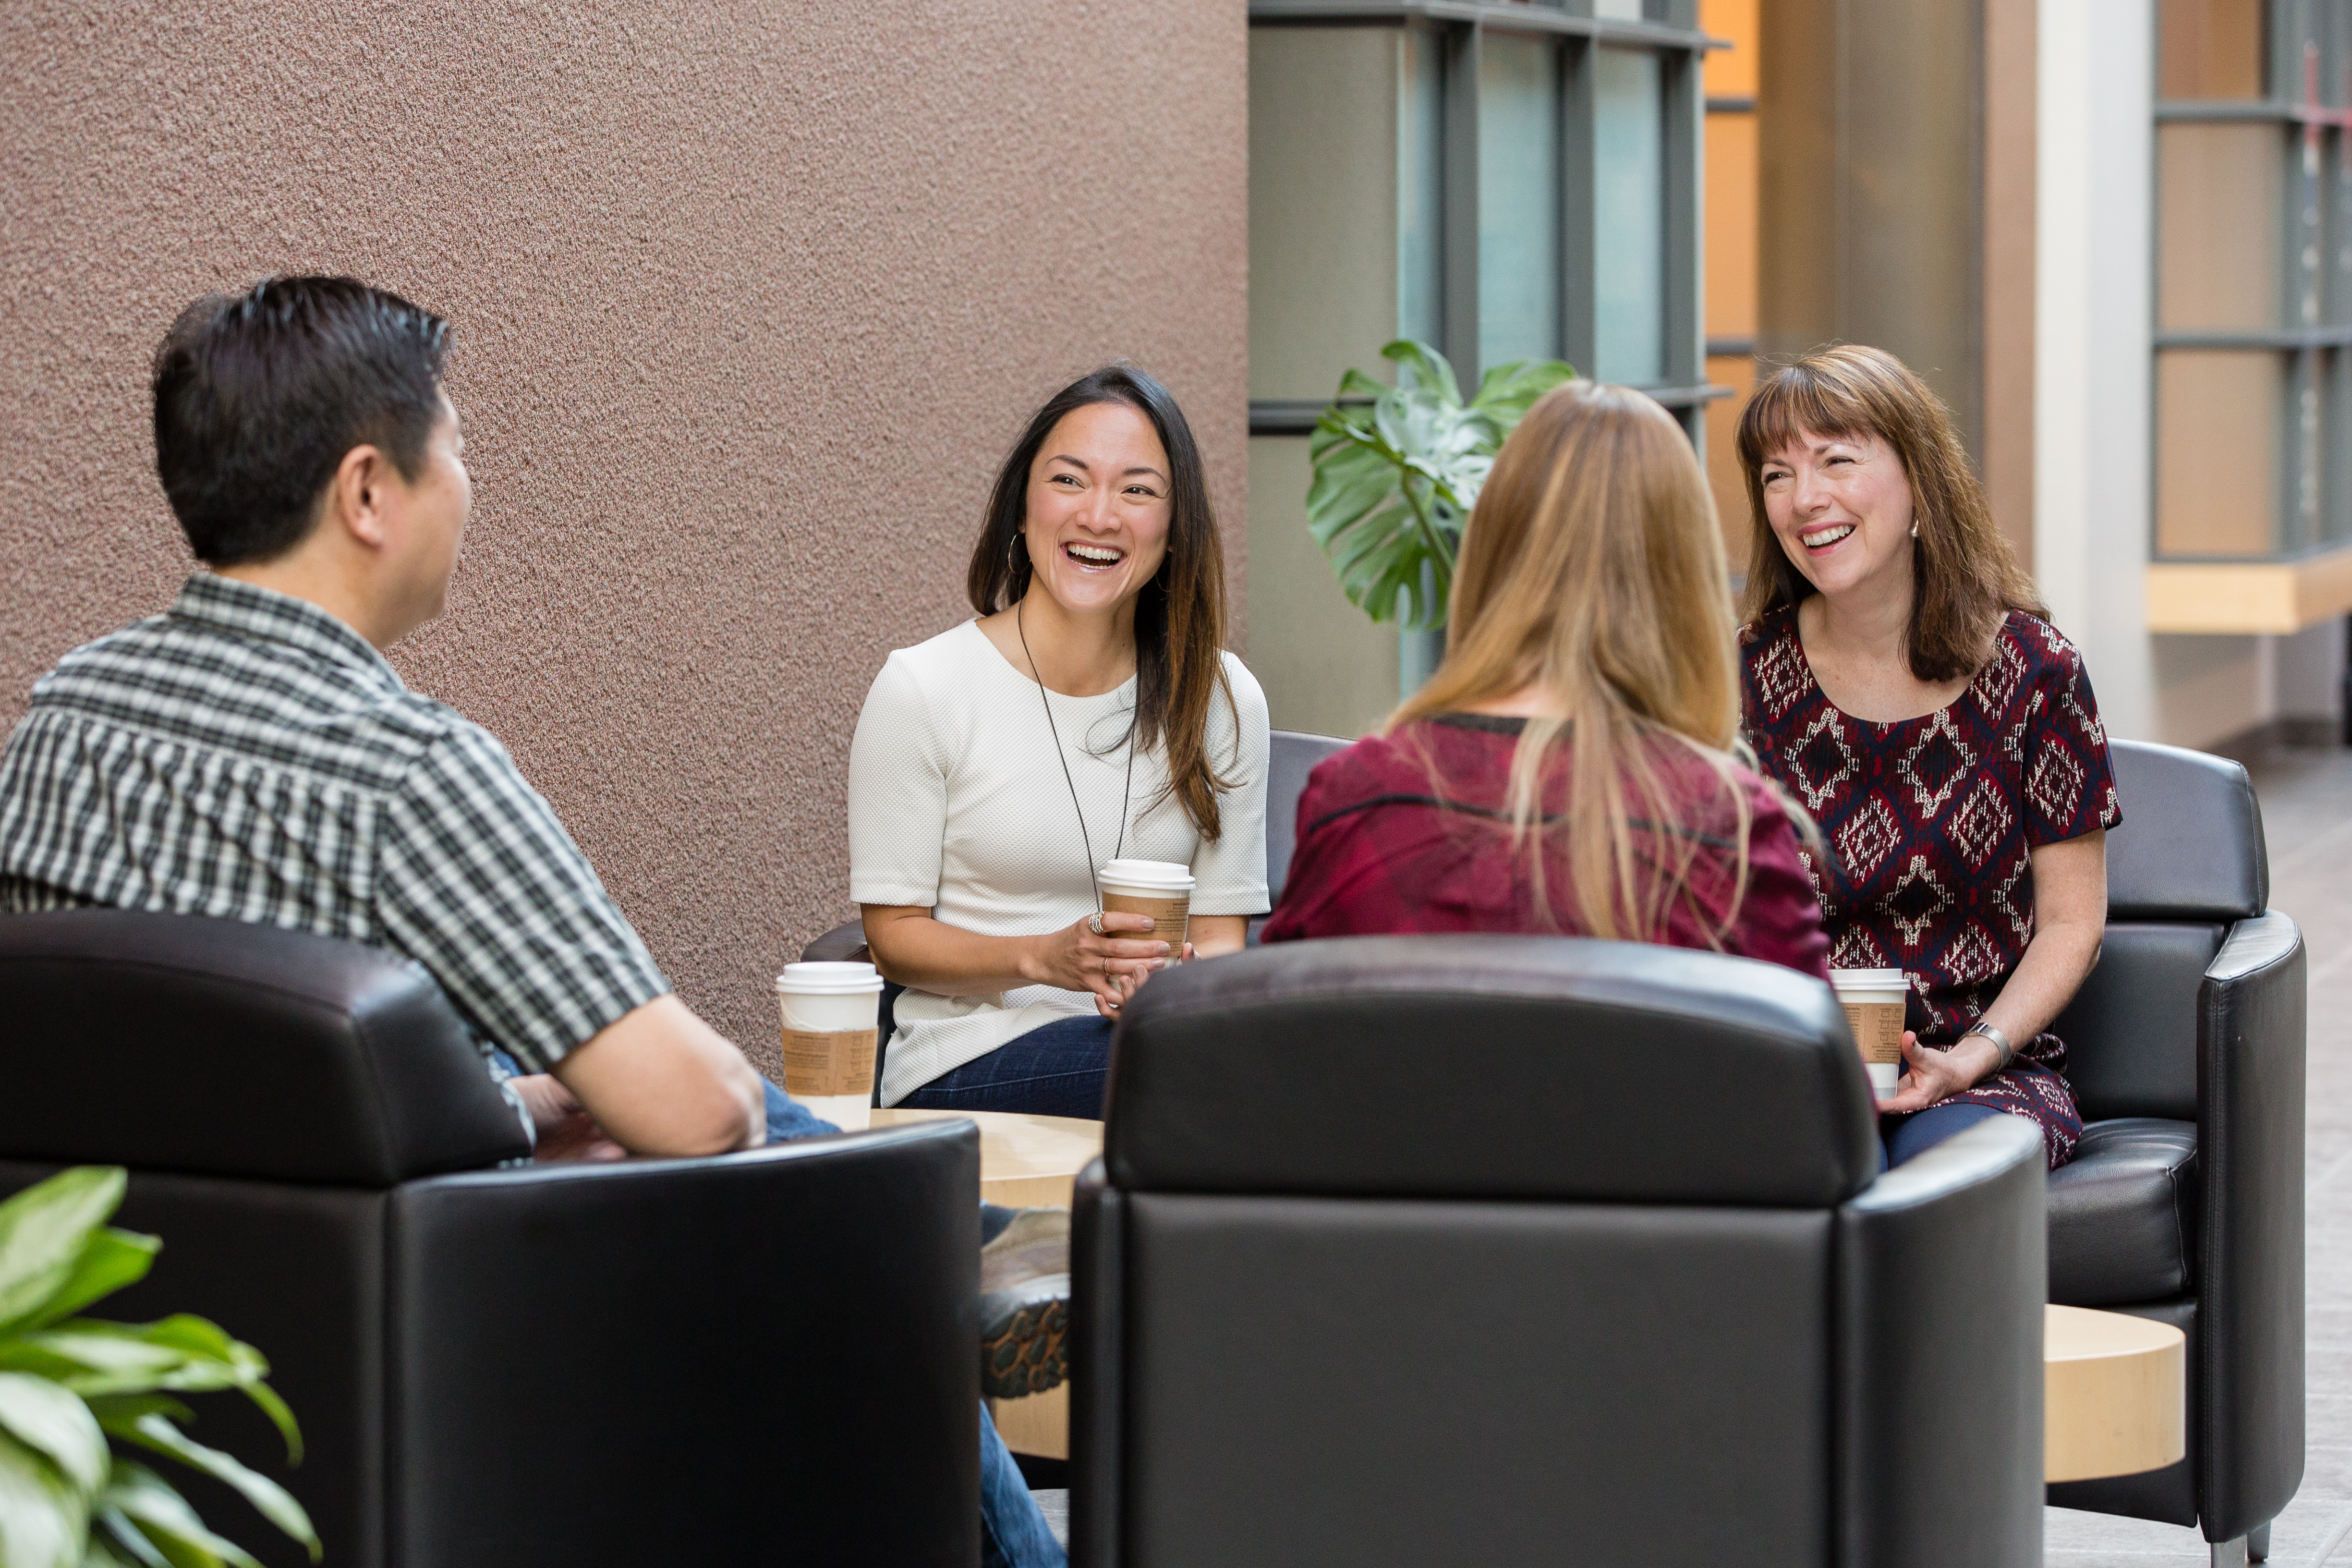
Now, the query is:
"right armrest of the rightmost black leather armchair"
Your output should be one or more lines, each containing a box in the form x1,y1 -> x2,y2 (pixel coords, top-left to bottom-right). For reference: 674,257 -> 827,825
2190,912 -> 2305,1540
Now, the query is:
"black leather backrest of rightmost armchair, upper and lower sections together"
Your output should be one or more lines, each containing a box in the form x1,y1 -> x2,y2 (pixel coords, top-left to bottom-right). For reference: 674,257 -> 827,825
2051,741 -> 2270,1121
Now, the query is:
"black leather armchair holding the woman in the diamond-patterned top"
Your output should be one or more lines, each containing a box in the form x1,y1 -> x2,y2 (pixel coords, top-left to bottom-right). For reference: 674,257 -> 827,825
2049,741 -> 2305,1558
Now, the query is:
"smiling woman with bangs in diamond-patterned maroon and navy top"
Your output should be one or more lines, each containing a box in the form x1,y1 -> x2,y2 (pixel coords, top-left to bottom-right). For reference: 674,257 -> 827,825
1741,348 -> 2122,1168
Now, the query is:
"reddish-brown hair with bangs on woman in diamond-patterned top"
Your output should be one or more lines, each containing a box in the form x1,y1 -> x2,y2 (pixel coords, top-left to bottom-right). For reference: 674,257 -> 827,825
1741,343 -> 2049,682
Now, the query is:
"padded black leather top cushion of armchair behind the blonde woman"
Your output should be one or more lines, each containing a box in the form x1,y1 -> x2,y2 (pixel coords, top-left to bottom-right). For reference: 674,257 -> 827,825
1105,936 -> 1877,1208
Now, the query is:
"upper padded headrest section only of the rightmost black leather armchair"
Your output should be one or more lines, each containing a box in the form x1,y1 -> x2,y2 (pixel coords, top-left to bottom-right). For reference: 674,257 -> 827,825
2108,741 -> 2270,924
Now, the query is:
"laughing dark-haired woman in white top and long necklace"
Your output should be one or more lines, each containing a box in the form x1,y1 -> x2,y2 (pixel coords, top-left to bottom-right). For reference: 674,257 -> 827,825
849,365 -> 1268,1117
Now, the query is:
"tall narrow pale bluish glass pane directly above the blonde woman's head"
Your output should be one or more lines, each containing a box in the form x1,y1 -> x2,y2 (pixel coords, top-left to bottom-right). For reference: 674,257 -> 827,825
1592,49 -> 1665,386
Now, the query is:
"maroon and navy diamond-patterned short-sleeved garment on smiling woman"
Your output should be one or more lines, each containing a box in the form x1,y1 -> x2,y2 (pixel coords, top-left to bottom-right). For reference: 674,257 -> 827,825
1741,609 -> 2124,1171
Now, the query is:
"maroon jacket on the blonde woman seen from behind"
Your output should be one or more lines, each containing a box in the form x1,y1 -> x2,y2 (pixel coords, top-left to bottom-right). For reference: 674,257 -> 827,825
1263,712 -> 1830,978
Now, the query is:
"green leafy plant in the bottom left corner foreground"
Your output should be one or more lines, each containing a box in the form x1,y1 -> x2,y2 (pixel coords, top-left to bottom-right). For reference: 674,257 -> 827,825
0,1166 -> 320,1568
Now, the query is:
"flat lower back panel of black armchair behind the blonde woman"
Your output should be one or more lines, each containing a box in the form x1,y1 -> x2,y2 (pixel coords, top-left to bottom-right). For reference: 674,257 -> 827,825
1110,1189 -> 1844,1566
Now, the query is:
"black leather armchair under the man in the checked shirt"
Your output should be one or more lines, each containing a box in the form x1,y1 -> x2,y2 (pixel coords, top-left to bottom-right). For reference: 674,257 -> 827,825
0,910 -> 979,1568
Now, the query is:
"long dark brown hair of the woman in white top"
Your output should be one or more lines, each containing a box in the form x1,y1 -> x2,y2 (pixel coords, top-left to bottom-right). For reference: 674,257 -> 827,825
964,365 -> 1239,841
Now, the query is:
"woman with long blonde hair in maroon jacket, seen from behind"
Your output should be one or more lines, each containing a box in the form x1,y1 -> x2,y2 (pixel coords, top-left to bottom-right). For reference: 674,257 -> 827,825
1265,381 -> 1828,975
